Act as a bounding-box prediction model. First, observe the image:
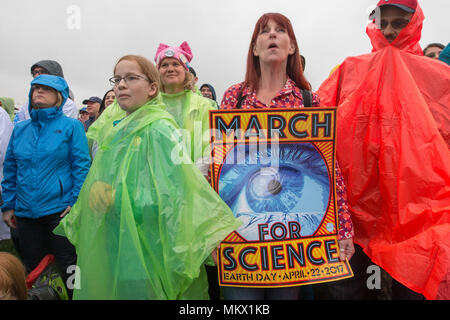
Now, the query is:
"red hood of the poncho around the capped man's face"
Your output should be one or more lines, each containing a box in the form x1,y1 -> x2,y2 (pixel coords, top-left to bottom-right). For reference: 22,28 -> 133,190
366,5 -> 425,56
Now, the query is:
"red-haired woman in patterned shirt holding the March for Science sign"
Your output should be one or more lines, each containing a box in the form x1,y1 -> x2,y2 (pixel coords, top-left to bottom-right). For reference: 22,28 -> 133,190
221,13 -> 354,300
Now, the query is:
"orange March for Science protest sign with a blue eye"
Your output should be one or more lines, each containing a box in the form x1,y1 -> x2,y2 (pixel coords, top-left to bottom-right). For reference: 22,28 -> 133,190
210,108 -> 353,287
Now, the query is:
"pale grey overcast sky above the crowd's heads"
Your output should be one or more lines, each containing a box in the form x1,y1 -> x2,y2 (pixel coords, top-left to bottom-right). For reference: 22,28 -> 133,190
0,0 -> 450,107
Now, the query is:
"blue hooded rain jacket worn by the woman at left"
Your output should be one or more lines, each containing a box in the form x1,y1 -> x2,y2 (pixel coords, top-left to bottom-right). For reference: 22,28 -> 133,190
2,75 -> 90,219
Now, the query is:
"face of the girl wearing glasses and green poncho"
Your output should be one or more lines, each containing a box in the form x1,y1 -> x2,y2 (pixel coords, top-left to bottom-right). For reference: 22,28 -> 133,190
114,60 -> 157,114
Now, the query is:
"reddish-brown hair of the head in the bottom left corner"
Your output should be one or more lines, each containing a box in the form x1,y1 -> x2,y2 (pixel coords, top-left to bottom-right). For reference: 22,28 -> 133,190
0,252 -> 27,300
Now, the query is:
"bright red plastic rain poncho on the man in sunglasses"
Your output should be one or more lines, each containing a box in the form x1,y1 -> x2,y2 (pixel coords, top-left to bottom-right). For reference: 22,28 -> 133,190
318,7 -> 450,299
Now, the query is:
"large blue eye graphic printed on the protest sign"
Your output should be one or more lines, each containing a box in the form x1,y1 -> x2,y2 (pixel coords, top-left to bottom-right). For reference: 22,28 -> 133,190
219,143 -> 330,241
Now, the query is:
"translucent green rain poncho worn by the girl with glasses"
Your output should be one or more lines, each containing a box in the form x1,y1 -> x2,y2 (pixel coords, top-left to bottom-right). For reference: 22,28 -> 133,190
55,99 -> 240,300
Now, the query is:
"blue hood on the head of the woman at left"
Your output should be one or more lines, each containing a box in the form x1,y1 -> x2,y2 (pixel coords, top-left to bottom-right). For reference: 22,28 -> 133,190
28,74 -> 69,120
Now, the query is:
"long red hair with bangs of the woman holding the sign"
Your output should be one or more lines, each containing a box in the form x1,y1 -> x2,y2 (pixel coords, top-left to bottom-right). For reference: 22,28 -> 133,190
244,13 -> 311,90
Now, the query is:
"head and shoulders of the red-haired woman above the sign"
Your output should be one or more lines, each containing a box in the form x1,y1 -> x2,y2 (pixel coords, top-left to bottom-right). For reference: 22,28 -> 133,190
221,13 -> 312,109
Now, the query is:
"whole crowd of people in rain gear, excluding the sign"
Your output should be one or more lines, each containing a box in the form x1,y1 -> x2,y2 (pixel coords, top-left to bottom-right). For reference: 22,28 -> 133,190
0,0 -> 450,300
